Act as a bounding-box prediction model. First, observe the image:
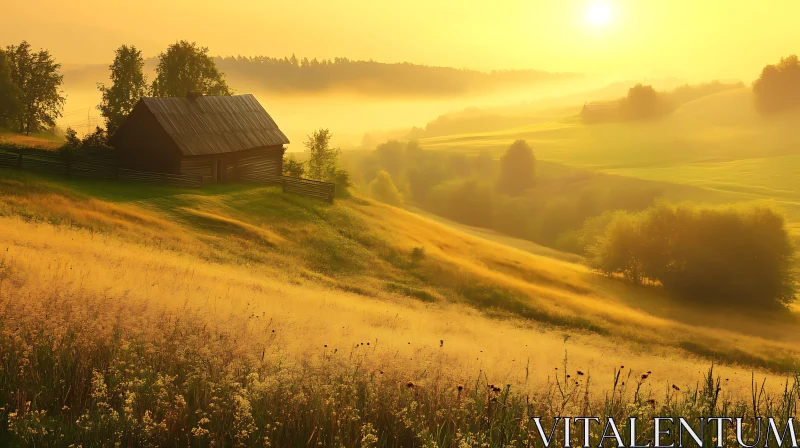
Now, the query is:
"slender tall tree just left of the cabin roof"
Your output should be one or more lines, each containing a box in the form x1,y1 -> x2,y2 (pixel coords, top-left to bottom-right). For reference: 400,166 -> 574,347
97,45 -> 148,135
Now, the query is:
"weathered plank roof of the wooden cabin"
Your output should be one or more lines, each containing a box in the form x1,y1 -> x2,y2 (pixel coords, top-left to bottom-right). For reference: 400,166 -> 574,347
119,94 -> 289,156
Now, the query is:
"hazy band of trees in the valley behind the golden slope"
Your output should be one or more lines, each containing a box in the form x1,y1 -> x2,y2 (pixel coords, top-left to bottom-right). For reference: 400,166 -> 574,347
343,140 -> 661,245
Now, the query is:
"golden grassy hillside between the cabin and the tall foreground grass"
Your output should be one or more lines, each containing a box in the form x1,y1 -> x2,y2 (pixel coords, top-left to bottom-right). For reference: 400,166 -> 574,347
0,171 -> 800,380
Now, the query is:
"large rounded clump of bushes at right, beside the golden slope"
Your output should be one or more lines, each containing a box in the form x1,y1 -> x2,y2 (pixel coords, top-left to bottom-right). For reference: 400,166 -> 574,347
588,203 -> 797,306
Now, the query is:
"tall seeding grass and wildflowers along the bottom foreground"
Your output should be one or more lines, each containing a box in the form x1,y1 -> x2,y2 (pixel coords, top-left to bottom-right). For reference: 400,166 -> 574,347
0,288 -> 800,447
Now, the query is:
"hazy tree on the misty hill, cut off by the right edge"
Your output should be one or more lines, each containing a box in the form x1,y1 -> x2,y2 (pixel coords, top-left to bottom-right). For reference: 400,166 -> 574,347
753,55 -> 800,113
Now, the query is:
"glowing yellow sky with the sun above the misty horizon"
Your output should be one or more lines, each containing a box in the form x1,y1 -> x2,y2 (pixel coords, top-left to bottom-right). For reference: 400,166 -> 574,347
0,0 -> 800,80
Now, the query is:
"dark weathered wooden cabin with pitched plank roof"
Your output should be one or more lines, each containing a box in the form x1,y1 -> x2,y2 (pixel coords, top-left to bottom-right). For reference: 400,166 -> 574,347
109,94 -> 289,183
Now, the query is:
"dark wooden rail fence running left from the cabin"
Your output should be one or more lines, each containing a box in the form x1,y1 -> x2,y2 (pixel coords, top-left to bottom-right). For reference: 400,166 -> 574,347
0,149 -> 203,188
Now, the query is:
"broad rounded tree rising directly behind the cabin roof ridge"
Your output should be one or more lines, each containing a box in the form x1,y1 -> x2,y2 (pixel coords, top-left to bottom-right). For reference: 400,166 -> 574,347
152,40 -> 233,97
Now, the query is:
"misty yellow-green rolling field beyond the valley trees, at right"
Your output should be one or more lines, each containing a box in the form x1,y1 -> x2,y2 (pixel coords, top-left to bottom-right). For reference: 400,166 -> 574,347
421,89 -> 800,234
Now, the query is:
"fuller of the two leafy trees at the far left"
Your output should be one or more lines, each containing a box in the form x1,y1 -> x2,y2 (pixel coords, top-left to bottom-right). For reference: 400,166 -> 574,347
6,41 -> 66,134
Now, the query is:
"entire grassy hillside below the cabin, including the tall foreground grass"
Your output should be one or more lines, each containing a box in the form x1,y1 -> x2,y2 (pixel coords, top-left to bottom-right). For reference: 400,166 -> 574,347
0,171 -> 800,446
